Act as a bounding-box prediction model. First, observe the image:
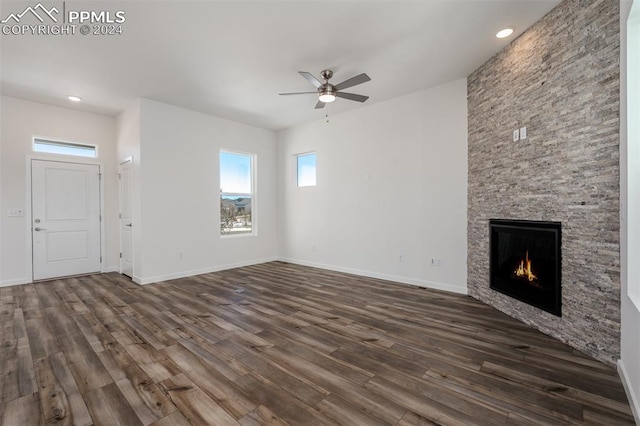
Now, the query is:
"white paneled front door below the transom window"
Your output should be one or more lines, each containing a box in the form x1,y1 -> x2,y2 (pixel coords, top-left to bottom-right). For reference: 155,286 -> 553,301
31,160 -> 101,280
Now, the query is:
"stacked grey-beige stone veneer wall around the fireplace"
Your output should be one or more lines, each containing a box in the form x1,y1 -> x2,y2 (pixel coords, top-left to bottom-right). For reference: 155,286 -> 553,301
467,0 -> 620,364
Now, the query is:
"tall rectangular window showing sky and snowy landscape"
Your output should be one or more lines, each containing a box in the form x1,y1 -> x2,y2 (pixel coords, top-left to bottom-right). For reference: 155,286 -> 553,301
220,151 -> 255,235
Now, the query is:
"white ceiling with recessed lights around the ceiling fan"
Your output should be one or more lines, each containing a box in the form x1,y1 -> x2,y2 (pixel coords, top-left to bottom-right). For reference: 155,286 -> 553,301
0,0 -> 559,130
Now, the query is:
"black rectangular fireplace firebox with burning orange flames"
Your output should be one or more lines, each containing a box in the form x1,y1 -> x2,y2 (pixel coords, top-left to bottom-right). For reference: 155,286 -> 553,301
489,219 -> 562,316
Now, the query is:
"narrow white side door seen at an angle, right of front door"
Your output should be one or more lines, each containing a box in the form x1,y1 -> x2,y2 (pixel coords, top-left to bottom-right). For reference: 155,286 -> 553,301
120,160 -> 133,278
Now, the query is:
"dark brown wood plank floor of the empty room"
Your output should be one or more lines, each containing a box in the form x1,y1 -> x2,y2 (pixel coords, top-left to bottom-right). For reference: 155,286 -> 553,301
0,262 -> 633,426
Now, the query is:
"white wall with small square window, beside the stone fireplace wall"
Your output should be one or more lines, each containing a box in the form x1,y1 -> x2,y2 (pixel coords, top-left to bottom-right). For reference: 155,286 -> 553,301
278,80 -> 467,293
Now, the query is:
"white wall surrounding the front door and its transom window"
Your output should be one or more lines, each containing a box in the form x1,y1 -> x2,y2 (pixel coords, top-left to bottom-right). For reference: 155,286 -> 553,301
0,97 -> 119,285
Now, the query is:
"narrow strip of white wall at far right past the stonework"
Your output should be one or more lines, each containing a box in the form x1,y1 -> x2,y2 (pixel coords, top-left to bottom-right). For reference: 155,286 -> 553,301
618,0 -> 640,424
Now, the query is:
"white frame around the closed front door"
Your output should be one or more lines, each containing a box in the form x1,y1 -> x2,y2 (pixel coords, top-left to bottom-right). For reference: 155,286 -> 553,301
24,153 -> 107,282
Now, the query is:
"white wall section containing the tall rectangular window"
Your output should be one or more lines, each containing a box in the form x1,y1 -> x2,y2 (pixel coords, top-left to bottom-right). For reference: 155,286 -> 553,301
134,99 -> 277,284
